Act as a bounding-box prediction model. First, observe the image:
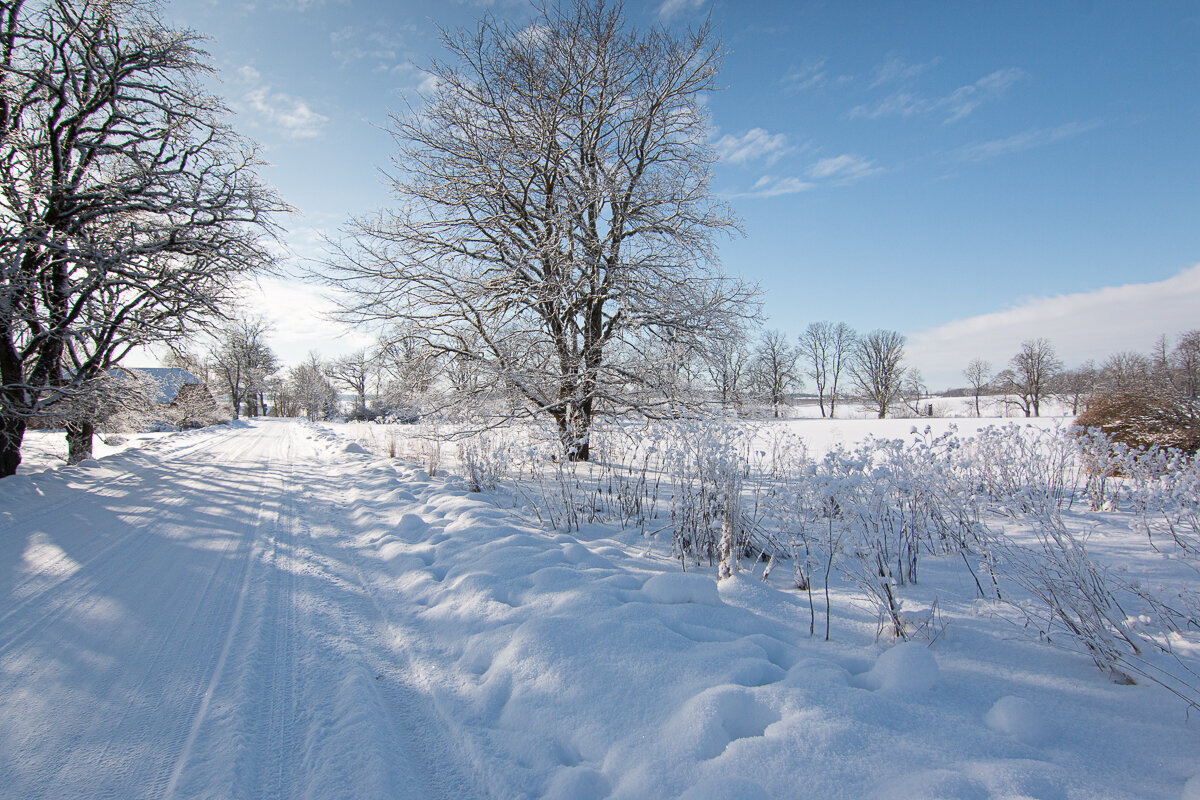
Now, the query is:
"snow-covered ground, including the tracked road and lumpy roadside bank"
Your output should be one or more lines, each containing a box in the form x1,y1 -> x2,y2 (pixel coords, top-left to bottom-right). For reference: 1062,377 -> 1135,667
0,420 -> 1200,800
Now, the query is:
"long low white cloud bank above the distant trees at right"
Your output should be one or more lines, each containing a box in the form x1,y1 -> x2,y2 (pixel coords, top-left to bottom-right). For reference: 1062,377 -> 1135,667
907,264 -> 1200,387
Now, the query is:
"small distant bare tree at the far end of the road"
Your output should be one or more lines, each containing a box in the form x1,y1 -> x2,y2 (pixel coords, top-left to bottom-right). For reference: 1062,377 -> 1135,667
209,317 -> 278,420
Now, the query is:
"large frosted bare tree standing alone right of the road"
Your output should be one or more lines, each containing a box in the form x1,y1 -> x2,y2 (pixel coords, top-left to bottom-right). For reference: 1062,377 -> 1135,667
321,0 -> 752,461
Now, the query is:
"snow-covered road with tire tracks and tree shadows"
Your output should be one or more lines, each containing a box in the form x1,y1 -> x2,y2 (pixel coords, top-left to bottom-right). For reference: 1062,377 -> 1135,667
0,422 -> 480,798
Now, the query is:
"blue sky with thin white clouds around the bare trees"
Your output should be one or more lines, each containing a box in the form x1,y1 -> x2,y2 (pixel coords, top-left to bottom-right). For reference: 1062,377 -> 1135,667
159,0 -> 1200,389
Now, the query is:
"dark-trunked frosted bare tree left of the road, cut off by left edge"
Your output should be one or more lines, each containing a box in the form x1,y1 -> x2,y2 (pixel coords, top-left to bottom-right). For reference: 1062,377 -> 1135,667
0,0 -> 284,476
